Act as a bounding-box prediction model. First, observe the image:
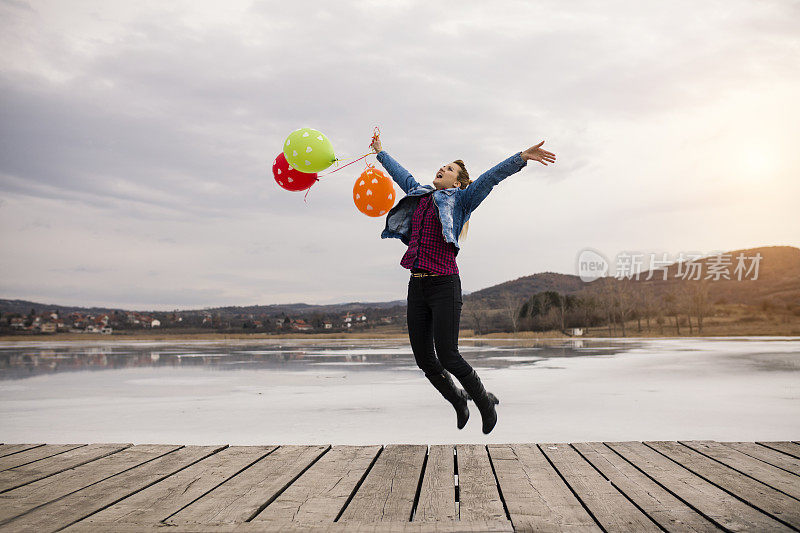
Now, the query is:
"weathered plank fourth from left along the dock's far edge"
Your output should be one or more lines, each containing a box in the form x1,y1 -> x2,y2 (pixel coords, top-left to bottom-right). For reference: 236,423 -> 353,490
0,444 -> 180,524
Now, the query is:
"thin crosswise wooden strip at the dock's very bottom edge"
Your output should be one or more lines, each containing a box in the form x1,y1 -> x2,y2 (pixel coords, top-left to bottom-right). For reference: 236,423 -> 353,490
62,520 -> 514,533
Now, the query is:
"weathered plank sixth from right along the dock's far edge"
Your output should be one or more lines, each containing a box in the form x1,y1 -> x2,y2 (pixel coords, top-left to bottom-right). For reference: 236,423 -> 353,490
572,442 -> 719,533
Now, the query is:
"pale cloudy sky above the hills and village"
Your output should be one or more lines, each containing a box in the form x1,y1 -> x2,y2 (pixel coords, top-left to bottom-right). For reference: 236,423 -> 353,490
0,0 -> 800,310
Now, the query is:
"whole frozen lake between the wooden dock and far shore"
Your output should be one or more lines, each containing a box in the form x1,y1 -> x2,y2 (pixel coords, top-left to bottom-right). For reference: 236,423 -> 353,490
0,337 -> 800,445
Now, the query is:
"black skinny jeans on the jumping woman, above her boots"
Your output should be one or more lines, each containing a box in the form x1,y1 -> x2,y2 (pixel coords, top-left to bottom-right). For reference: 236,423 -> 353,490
407,274 -> 472,379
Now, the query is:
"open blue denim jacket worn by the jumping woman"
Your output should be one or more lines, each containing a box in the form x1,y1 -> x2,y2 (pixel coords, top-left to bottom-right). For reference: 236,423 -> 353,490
378,150 -> 528,255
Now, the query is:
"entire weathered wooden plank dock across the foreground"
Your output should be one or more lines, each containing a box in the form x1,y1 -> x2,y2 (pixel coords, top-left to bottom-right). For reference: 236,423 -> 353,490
0,441 -> 800,533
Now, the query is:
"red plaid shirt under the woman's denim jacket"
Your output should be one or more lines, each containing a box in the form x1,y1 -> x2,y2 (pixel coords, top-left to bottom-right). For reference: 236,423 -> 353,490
400,193 -> 458,274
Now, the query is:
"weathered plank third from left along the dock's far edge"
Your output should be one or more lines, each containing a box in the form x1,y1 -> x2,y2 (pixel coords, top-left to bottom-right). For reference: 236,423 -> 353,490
0,444 -> 132,492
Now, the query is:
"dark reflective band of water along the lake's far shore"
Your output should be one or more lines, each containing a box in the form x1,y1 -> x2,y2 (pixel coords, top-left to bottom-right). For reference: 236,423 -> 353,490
0,339 -> 637,380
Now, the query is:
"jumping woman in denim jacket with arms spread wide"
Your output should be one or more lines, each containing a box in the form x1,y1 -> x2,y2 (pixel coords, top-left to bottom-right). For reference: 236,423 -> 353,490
371,133 -> 556,433
